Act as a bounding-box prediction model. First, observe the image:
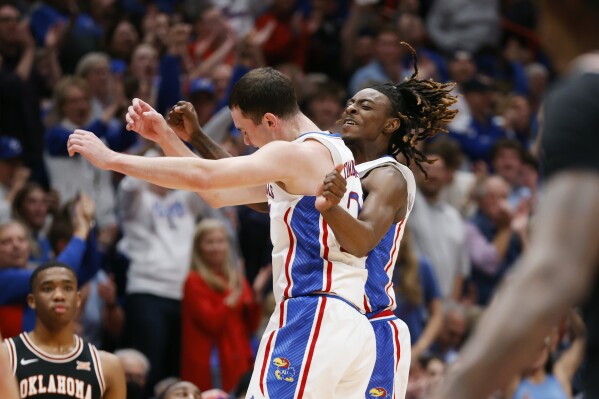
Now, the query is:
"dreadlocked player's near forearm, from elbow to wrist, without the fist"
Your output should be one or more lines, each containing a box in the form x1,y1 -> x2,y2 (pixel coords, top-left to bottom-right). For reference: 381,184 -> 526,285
321,205 -> 377,257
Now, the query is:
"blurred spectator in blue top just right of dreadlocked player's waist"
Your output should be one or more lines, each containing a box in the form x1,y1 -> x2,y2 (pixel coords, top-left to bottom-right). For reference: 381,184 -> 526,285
394,229 -> 443,361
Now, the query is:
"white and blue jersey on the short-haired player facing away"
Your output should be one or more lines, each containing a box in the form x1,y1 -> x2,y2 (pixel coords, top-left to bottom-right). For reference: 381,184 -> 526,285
267,132 -> 367,311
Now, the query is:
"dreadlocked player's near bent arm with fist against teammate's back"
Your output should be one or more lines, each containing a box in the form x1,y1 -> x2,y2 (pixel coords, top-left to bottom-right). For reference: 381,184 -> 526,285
316,166 -> 408,257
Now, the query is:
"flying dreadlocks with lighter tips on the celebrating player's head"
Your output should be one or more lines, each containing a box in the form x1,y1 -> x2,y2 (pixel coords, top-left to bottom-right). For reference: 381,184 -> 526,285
371,42 -> 458,175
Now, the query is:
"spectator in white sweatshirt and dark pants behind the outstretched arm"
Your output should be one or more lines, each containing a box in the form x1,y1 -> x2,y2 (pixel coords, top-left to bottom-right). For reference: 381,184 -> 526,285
117,150 -> 218,392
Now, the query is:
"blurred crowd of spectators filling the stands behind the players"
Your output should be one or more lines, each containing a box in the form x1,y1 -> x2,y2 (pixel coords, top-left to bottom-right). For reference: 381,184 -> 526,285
0,0 -> 584,399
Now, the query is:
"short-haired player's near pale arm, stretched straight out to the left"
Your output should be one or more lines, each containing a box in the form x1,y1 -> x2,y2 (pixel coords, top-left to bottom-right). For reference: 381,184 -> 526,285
68,129 -> 333,205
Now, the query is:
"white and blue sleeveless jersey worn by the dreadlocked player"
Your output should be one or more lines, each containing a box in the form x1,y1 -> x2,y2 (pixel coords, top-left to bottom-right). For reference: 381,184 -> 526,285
356,156 -> 416,317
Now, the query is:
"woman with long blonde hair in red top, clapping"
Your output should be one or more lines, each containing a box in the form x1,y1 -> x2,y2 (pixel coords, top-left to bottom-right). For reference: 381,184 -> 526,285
181,219 -> 270,391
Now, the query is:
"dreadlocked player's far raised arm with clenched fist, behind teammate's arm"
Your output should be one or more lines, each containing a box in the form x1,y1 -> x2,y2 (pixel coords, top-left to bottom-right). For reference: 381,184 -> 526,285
166,101 -> 268,213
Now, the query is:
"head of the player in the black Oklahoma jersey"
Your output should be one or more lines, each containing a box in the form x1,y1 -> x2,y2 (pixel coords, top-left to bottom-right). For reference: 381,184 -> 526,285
27,267 -> 81,328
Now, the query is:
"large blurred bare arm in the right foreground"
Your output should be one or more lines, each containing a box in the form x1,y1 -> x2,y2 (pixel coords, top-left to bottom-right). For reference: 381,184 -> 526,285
433,172 -> 599,399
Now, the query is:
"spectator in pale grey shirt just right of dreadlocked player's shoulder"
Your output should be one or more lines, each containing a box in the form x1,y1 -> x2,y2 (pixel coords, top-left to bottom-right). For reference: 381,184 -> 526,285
408,151 -> 470,300
